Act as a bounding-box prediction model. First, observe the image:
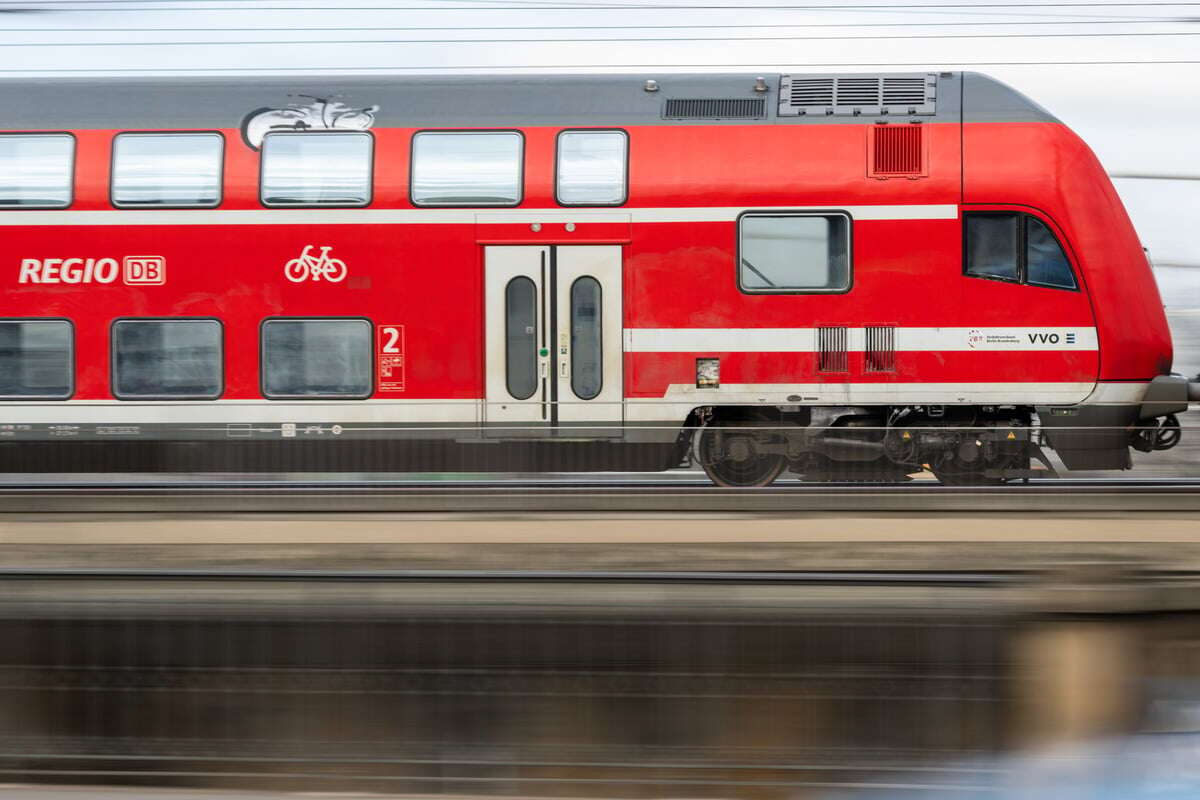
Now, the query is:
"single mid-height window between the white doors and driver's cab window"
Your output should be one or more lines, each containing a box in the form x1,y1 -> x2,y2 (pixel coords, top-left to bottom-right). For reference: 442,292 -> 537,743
738,212 -> 850,294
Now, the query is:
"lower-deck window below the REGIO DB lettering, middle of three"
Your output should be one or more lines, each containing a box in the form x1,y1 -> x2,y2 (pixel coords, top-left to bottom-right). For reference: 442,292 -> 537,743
112,319 -> 223,399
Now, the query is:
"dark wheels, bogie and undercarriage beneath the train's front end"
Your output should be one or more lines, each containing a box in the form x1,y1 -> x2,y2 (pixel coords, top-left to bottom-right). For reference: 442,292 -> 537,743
688,405 -> 1181,487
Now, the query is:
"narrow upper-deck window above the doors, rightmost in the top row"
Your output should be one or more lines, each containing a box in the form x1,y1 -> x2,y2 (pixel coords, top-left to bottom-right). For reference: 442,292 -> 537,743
554,131 -> 629,205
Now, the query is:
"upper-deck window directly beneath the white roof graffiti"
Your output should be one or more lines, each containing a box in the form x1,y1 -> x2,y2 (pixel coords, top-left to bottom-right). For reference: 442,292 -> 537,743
259,131 -> 374,206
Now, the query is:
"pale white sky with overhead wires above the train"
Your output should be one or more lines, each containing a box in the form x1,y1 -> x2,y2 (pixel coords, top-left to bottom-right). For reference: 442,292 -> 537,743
0,0 -> 1200,265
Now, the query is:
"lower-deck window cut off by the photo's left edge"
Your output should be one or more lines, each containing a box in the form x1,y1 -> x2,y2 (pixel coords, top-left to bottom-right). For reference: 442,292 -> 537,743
0,319 -> 74,399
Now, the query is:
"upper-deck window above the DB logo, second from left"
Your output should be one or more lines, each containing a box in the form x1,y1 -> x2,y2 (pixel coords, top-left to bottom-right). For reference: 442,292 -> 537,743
112,133 -> 224,207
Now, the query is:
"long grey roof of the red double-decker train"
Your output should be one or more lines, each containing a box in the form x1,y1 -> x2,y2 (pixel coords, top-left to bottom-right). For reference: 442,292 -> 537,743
0,72 -> 1057,131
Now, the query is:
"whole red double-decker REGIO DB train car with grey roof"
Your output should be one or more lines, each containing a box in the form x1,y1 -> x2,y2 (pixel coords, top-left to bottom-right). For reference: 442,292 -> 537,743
0,72 -> 1198,486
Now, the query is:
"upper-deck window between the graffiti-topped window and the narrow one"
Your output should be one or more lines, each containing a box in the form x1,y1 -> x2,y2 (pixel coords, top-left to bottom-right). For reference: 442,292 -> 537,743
412,131 -> 524,205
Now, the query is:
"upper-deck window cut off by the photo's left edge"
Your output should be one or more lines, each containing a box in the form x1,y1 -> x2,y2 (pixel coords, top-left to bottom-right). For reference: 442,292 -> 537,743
0,133 -> 74,209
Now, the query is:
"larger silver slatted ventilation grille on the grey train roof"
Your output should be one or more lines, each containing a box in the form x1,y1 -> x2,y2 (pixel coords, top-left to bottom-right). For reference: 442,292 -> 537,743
779,72 -> 937,116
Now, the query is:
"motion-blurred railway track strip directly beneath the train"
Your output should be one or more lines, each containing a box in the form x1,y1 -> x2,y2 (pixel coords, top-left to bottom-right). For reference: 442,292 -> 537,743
0,477 -> 1200,513
